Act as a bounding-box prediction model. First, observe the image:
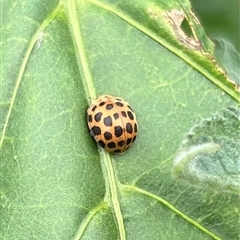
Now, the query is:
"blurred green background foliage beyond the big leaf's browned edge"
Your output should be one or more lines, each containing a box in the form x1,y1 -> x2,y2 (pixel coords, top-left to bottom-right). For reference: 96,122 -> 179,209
191,0 -> 240,85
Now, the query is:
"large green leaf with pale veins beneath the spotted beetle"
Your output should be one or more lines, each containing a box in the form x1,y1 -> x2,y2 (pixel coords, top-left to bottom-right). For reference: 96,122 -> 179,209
0,0 -> 240,240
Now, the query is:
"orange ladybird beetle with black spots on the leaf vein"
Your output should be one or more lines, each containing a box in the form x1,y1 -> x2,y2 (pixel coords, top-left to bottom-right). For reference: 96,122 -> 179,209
87,95 -> 138,153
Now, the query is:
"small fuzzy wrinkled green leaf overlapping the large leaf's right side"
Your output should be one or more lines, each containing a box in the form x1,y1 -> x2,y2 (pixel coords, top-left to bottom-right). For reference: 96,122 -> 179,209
173,107 -> 240,194
